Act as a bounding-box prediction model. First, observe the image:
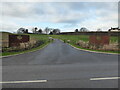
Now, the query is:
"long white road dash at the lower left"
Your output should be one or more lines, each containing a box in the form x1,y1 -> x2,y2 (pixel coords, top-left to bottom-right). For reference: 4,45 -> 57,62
0,80 -> 47,84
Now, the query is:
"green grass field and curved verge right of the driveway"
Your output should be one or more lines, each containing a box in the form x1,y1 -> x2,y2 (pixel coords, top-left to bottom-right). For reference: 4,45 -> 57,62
51,35 -> 120,53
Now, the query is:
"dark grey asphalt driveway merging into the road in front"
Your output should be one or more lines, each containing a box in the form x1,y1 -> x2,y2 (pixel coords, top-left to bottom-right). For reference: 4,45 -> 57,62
0,40 -> 118,88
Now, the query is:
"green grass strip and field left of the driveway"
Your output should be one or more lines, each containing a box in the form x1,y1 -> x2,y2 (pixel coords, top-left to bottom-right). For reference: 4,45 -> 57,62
2,34 -> 50,56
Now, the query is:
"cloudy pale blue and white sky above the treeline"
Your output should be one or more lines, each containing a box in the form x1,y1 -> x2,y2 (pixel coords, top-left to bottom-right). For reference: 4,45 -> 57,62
0,2 -> 118,32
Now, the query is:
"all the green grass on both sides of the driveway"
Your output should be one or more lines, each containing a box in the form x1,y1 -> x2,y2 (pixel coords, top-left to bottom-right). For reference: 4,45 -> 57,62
1,33 -> 120,56
